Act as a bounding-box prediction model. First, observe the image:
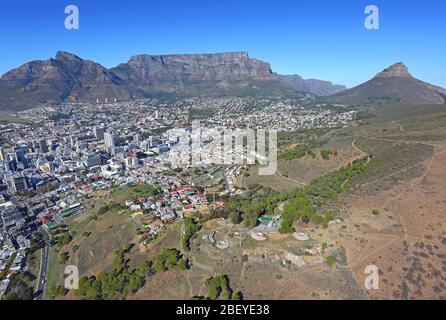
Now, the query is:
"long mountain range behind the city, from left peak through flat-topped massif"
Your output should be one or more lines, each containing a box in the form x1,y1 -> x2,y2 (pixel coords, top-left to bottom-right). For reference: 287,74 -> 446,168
0,52 -> 344,110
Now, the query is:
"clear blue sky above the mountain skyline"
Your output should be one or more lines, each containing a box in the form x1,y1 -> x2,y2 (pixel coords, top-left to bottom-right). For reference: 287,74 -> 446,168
0,0 -> 446,87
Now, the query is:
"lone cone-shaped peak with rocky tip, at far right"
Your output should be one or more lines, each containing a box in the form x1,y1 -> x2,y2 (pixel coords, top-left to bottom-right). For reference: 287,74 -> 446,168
327,62 -> 446,104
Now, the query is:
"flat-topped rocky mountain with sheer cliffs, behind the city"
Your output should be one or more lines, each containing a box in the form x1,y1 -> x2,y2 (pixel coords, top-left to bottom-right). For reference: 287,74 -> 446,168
111,52 -> 293,96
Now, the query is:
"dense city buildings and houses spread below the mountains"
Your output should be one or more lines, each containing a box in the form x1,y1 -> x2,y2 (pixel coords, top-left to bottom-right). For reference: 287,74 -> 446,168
0,98 -> 355,297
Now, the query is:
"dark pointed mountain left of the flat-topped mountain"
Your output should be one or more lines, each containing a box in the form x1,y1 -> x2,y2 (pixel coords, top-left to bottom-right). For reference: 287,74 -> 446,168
0,52 -> 142,110
